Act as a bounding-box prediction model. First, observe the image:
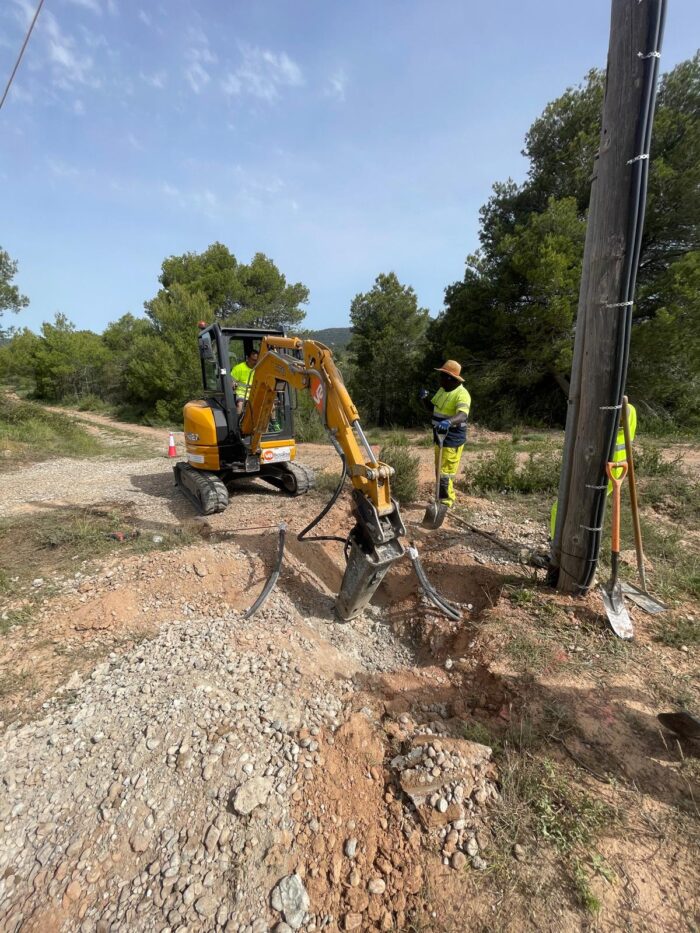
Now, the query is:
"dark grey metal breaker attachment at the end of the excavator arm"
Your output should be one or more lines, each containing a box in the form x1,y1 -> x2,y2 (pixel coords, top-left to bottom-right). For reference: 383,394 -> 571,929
335,489 -> 406,622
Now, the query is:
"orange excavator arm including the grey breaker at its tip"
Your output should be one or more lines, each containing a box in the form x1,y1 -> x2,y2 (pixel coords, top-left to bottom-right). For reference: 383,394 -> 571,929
241,337 -> 406,620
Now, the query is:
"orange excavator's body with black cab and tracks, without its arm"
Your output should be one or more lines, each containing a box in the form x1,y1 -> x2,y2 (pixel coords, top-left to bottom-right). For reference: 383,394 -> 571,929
175,324 -> 314,515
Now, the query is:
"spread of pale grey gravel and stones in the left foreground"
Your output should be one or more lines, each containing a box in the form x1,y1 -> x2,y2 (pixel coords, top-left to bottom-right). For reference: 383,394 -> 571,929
0,545 -> 416,931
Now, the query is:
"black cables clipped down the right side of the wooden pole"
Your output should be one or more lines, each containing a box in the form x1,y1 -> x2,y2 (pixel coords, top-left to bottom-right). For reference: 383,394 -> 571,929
580,0 -> 666,593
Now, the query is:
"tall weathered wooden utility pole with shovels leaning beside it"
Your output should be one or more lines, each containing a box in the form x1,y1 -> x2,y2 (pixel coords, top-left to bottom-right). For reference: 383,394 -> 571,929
551,0 -> 664,594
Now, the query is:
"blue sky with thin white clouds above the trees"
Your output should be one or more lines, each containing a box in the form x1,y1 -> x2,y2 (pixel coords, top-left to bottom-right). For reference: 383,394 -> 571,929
0,0 -> 700,330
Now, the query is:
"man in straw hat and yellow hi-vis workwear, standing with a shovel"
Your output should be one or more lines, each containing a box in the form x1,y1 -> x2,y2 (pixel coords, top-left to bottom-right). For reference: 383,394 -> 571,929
419,360 -> 472,508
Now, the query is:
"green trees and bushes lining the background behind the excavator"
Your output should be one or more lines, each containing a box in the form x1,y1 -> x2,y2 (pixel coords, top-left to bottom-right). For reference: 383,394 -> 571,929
0,53 -> 700,429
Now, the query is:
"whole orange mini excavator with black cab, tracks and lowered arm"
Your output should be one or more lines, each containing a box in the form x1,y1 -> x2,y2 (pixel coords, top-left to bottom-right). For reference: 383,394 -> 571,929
175,324 -> 406,620
